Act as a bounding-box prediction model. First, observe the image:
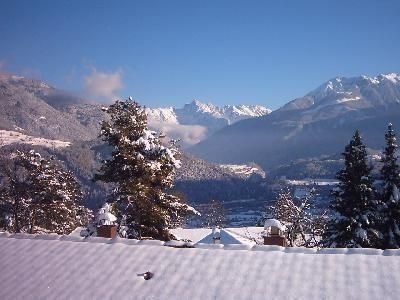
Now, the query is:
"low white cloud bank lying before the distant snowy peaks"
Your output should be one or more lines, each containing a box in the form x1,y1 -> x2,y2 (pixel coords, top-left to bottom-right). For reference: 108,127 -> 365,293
149,119 -> 207,147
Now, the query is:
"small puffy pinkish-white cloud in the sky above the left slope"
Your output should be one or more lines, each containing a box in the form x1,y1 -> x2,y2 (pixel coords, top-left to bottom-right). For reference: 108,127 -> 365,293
83,68 -> 124,101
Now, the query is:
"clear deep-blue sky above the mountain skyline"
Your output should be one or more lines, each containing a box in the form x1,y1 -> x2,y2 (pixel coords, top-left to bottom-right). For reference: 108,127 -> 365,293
0,0 -> 400,108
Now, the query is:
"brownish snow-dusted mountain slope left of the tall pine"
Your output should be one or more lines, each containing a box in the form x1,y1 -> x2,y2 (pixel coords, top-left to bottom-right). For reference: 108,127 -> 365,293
0,74 -> 104,141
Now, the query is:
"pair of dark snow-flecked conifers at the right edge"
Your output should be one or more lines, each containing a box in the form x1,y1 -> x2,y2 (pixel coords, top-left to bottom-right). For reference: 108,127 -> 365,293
323,124 -> 400,249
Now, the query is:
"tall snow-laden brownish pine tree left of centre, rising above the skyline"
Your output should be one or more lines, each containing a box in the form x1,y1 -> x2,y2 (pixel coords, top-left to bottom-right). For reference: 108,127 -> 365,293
95,97 -> 197,240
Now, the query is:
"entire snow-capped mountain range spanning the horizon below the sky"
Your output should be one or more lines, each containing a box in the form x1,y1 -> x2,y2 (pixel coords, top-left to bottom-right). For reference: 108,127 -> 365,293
0,73 -> 400,176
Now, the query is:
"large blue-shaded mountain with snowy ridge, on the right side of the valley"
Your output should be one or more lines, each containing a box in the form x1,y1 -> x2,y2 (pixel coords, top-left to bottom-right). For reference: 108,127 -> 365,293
189,73 -> 400,171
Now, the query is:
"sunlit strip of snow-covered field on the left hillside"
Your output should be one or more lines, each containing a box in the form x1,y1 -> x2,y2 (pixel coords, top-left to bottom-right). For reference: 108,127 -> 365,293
0,130 -> 71,148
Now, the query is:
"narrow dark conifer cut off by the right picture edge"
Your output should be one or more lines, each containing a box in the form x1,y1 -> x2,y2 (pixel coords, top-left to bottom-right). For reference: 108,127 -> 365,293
381,123 -> 400,249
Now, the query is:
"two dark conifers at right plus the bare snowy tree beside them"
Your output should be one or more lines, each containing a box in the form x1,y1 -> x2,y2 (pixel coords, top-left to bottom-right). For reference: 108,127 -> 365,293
264,124 -> 400,249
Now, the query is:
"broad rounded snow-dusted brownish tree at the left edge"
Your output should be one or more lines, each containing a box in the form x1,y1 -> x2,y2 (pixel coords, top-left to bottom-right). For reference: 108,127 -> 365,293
0,150 -> 90,234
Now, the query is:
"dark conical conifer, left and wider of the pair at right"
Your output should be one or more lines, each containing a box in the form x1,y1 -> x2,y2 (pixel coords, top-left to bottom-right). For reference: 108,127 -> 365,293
324,130 -> 382,248
